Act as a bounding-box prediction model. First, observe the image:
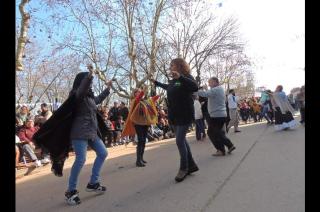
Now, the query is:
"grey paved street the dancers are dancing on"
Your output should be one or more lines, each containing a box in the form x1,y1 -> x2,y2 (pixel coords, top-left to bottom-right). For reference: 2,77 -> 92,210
16,118 -> 305,212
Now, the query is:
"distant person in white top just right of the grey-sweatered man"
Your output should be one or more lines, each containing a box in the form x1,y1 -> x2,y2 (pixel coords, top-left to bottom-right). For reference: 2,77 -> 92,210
227,89 -> 241,133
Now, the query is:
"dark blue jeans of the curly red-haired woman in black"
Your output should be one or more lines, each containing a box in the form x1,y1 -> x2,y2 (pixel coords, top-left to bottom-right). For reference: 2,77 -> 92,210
175,125 -> 196,171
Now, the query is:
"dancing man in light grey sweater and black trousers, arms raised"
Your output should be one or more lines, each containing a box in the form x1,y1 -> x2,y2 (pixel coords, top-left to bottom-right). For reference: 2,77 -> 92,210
198,77 -> 235,156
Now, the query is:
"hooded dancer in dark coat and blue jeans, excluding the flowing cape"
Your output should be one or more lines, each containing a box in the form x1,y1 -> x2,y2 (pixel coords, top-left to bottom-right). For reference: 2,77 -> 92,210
65,66 -> 111,205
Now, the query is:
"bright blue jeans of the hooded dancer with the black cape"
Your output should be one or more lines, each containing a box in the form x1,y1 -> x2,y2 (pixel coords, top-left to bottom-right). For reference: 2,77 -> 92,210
68,138 -> 108,191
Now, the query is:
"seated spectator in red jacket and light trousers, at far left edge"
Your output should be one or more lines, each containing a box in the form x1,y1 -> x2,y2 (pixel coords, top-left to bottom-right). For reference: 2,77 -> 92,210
18,117 -> 50,167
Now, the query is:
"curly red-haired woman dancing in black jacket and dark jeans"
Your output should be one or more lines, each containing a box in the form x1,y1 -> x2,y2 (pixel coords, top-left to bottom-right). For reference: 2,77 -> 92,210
153,58 -> 199,182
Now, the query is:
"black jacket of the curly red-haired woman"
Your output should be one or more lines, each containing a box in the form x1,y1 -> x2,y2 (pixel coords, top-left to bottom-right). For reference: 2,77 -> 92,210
155,75 -> 198,125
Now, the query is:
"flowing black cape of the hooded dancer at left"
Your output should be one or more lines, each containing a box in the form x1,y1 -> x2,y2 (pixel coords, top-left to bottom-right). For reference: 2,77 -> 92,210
33,95 -> 107,176
